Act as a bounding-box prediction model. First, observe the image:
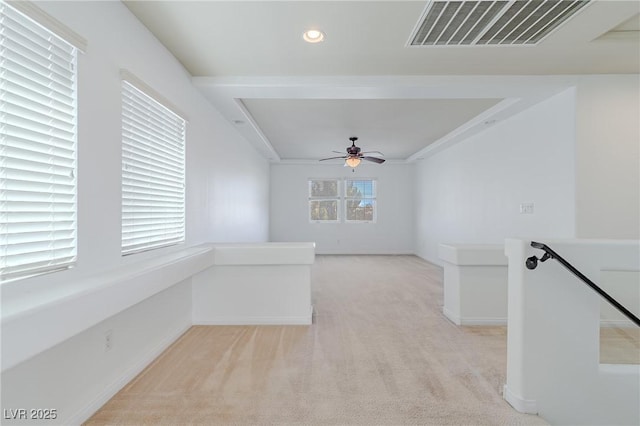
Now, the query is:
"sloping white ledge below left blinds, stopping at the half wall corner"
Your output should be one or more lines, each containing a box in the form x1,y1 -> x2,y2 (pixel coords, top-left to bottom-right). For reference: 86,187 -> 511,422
1,245 -> 213,371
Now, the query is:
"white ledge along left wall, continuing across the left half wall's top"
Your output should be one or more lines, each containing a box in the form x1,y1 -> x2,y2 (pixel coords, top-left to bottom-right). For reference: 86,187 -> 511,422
2,242 -> 315,371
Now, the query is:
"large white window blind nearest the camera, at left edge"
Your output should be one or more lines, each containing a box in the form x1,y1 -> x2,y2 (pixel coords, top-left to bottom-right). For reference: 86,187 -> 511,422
0,2 -> 77,281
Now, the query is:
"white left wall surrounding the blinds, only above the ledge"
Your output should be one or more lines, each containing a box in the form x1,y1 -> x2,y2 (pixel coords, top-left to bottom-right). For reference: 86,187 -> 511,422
3,1 -> 269,300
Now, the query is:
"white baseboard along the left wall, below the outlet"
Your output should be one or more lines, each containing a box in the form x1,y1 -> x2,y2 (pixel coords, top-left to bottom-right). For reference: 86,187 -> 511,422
66,324 -> 191,425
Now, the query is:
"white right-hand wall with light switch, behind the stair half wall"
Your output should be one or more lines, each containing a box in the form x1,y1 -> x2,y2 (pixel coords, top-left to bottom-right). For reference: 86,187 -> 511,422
415,89 -> 575,264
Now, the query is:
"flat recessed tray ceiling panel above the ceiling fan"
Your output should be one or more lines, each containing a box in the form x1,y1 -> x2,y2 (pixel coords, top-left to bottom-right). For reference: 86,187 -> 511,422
242,99 -> 501,160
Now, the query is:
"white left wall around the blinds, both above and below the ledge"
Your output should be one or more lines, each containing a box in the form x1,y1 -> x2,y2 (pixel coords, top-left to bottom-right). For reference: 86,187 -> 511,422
1,2 -> 269,424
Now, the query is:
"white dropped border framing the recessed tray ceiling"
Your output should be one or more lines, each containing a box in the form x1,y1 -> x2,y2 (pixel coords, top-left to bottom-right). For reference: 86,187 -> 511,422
192,75 -> 580,163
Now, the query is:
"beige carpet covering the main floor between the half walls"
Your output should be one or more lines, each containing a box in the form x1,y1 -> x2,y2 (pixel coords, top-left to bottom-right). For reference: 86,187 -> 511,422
87,256 -> 546,425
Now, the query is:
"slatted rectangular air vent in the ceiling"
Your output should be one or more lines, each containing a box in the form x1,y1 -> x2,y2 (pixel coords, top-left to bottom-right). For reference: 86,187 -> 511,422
410,0 -> 590,46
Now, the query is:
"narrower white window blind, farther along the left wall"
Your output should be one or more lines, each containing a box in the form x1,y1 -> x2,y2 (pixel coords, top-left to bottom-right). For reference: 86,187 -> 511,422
122,80 -> 185,254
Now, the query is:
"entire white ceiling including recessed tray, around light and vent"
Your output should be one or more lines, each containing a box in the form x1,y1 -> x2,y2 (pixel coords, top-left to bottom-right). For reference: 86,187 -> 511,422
125,0 -> 640,161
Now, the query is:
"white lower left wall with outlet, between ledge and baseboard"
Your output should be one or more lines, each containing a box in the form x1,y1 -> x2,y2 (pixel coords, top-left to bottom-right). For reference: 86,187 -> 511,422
2,280 -> 191,425
